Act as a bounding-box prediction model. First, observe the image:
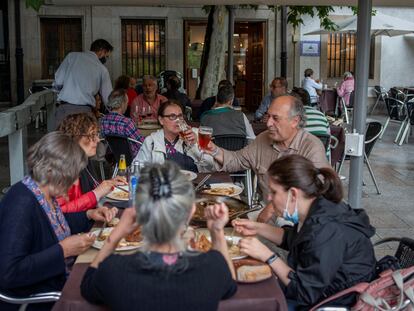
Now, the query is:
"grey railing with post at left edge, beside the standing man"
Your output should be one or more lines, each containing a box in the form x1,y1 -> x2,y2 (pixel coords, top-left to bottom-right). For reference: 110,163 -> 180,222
0,90 -> 56,185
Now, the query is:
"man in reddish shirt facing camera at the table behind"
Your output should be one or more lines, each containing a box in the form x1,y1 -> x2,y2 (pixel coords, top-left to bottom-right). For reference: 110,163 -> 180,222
131,76 -> 168,124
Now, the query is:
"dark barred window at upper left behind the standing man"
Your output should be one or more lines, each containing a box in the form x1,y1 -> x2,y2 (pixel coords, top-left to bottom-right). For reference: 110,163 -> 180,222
40,18 -> 82,79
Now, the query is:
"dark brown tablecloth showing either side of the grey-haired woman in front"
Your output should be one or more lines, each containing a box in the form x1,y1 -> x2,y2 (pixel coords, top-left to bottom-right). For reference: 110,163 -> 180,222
53,263 -> 287,311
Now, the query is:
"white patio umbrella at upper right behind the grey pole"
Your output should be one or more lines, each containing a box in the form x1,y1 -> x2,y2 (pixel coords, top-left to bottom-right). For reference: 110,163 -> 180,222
305,12 -> 414,37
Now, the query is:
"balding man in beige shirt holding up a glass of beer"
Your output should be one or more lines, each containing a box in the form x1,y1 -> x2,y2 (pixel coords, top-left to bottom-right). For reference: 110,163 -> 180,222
208,95 -> 330,222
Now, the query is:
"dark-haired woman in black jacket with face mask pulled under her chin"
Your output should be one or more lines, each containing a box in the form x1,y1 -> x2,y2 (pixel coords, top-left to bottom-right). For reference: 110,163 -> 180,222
233,155 -> 376,310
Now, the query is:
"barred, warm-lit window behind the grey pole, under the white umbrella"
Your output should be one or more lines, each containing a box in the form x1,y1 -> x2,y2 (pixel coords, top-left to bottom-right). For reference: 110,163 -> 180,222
327,33 -> 375,79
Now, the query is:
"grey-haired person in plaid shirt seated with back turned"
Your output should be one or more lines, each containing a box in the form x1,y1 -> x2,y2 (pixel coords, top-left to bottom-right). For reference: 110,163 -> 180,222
99,89 -> 144,157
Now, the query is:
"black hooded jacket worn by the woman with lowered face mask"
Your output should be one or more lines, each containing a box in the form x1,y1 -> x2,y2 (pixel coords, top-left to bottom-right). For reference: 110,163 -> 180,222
282,197 -> 376,309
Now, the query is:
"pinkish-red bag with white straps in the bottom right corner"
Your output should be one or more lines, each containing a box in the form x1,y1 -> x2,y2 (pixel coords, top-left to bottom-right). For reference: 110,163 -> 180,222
311,266 -> 414,311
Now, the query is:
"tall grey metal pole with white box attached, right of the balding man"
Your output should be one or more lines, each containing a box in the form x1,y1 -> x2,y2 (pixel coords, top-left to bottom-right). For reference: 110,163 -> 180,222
348,0 -> 372,209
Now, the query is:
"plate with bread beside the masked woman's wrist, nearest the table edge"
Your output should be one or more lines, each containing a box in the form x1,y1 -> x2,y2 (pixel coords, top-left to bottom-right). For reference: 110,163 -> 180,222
233,258 -> 273,283
